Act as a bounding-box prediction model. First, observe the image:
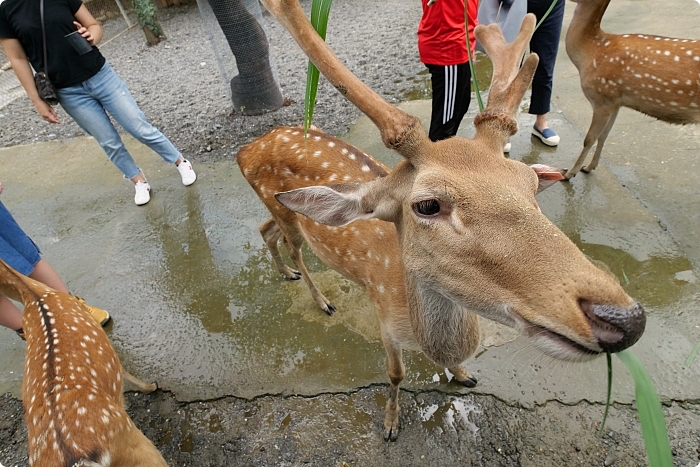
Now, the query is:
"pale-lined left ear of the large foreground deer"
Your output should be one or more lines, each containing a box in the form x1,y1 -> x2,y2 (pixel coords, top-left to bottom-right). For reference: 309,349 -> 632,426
275,183 -> 377,227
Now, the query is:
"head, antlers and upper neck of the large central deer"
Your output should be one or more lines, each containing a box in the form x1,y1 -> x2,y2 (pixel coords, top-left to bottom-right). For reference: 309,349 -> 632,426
263,0 -> 645,366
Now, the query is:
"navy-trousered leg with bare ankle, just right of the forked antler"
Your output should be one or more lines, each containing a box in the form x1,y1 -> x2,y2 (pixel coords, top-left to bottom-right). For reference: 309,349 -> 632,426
528,0 -> 565,126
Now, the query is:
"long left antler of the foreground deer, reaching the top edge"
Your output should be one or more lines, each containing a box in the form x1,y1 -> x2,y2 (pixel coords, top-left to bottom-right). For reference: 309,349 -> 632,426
261,0 -> 430,160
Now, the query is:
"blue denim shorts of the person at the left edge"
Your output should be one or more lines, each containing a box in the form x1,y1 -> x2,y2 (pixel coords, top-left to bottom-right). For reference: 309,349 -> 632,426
0,202 -> 41,276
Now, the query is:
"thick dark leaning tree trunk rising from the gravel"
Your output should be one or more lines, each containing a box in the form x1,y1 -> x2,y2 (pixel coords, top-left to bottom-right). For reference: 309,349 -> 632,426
209,0 -> 284,115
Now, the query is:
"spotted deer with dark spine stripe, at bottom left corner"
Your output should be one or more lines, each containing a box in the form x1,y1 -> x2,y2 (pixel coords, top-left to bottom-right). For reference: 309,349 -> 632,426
0,260 -> 167,467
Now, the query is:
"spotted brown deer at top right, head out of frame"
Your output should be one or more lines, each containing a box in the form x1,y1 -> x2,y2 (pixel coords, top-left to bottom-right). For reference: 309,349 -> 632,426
565,0 -> 700,179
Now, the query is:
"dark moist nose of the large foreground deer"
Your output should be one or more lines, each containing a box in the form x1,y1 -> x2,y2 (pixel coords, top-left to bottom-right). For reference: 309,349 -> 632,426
580,300 -> 647,353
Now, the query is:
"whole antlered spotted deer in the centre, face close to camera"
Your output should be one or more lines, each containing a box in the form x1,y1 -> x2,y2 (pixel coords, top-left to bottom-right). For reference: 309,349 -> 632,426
237,0 -> 646,440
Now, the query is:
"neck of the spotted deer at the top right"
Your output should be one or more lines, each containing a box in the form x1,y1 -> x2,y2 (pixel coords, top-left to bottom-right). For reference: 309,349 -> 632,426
566,0 -> 610,67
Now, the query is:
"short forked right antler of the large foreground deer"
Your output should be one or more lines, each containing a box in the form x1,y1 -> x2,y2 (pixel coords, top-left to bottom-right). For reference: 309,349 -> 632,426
474,13 -> 539,146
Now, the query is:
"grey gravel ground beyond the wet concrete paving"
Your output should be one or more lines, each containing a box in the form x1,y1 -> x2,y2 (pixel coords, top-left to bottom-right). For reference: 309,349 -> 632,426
0,0 -> 425,162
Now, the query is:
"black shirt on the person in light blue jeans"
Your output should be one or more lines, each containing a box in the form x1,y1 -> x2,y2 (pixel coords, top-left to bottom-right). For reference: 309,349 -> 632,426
0,0 -> 105,89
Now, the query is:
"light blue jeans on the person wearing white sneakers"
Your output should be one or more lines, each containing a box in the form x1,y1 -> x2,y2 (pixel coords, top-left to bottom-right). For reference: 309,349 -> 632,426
57,62 -> 180,178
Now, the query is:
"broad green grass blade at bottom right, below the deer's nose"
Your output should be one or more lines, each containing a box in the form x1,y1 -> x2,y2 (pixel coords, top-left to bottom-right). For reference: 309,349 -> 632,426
617,350 -> 673,467
